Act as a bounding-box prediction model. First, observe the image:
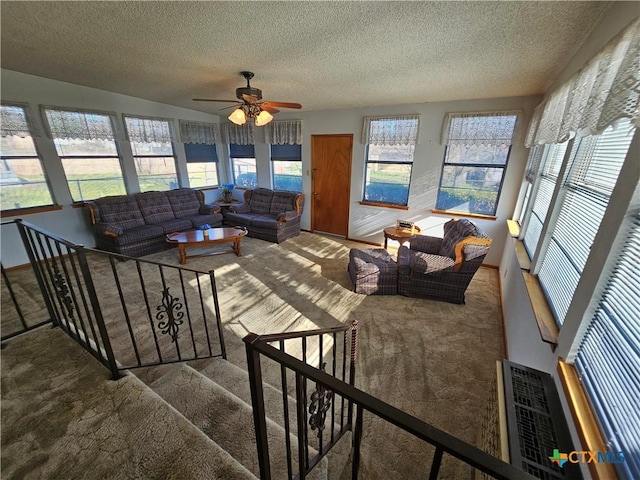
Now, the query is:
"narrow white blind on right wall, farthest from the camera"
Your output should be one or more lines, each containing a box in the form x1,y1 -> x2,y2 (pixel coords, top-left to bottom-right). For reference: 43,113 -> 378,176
522,142 -> 567,258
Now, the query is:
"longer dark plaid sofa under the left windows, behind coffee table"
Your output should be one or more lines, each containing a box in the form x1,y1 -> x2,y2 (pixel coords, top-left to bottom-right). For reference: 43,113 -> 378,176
85,188 -> 222,257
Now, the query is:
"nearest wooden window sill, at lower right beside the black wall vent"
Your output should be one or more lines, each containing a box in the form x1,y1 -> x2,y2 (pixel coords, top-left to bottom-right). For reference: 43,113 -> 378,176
558,360 -> 618,480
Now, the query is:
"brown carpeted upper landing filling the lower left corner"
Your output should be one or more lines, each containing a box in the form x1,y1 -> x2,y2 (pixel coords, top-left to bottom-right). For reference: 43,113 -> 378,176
1,326 -> 257,480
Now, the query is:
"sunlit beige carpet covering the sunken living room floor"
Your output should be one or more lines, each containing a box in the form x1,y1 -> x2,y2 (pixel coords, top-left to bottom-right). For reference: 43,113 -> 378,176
2,232 -> 503,479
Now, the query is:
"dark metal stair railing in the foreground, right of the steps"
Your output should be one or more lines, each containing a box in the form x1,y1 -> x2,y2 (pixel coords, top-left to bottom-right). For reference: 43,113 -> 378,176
243,332 -> 536,480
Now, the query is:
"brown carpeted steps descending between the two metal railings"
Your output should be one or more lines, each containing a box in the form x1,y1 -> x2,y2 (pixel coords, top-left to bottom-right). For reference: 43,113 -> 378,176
146,358 -> 351,480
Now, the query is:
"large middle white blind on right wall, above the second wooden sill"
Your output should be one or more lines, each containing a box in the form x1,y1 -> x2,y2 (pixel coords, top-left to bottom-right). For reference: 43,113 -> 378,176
538,119 -> 634,325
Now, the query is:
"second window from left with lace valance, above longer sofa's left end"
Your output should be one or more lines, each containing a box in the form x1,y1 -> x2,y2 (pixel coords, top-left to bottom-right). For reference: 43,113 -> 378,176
43,107 -> 126,202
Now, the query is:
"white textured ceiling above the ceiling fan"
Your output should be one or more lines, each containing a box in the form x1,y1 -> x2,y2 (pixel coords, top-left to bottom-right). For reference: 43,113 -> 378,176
0,0 -> 610,113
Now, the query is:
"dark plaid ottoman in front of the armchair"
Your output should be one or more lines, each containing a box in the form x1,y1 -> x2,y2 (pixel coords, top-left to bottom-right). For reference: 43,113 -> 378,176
348,248 -> 398,295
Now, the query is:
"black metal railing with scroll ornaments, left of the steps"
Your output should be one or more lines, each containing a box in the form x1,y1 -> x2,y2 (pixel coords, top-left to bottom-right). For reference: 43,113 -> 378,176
3,220 -> 226,379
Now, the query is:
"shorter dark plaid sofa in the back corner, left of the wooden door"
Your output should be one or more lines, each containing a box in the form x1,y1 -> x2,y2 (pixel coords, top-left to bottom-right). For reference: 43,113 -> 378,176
225,188 -> 304,243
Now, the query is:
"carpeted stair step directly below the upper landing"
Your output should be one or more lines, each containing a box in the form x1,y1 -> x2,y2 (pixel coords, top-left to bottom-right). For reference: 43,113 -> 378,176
150,365 -> 328,479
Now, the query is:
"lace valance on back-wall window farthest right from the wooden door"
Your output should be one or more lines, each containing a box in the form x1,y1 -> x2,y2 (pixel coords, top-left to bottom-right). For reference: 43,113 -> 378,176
441,111 -> 521,145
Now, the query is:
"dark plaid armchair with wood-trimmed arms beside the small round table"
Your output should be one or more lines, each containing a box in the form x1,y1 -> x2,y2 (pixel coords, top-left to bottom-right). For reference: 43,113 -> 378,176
398,219 -> 492,303
